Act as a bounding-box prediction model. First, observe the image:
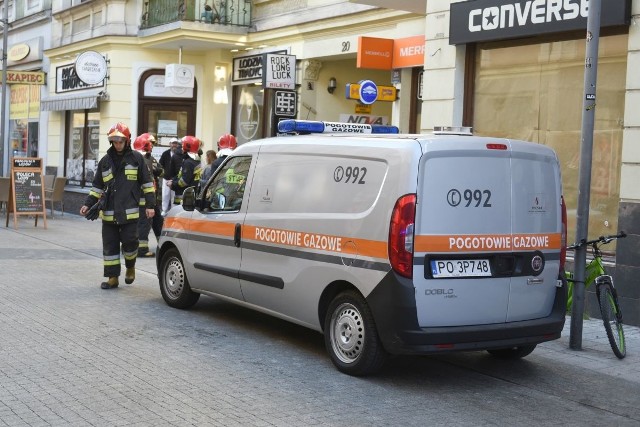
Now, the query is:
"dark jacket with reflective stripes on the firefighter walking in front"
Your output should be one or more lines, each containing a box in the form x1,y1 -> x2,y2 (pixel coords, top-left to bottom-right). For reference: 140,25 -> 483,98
85,147 -> 155,224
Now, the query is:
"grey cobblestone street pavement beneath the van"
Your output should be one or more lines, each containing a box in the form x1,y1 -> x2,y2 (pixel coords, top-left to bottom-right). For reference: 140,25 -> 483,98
0,213 -> 640,426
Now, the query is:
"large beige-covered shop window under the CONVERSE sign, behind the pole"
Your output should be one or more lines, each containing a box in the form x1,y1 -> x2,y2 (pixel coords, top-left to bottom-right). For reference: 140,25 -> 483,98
473,34 -> 628,244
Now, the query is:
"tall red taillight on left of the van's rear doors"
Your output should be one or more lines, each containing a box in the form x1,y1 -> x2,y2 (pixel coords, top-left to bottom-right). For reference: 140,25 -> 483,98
389,194 -> 416,279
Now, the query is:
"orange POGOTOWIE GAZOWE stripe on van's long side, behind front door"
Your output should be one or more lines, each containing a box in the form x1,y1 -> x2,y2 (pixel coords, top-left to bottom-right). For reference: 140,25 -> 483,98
242,225 -> 387,259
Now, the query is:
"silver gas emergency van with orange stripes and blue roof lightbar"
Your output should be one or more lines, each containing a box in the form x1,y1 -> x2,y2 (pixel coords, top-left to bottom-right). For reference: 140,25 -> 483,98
157,120 -> 566,375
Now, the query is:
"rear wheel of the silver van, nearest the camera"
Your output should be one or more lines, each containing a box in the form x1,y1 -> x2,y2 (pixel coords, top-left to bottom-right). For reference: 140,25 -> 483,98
324,291 -> 387,376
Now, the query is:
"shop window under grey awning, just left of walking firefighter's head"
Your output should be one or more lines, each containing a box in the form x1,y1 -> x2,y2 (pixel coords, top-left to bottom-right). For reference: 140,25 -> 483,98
65,111 -> 100,187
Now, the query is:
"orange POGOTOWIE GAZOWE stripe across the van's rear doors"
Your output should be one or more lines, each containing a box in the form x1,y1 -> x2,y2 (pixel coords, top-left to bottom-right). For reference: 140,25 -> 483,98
415,233 -> 561,253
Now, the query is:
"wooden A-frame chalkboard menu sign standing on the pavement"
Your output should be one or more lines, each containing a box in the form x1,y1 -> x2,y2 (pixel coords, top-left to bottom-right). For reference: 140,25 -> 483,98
5,157 -> 47,228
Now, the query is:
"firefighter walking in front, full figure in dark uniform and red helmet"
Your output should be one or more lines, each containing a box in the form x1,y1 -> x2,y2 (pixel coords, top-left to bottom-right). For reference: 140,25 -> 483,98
80,123 -> 155,289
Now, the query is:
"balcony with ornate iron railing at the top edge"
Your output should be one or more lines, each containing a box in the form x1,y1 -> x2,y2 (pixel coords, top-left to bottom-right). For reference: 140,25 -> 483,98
140,0 -> 251,29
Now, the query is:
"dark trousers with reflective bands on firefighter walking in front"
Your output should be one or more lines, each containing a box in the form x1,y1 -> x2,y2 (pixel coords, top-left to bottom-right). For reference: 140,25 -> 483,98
102,221 -> 138,277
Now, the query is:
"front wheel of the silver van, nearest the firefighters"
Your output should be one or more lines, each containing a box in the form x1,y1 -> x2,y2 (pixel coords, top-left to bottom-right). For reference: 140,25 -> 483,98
159,248 -> 200,308
